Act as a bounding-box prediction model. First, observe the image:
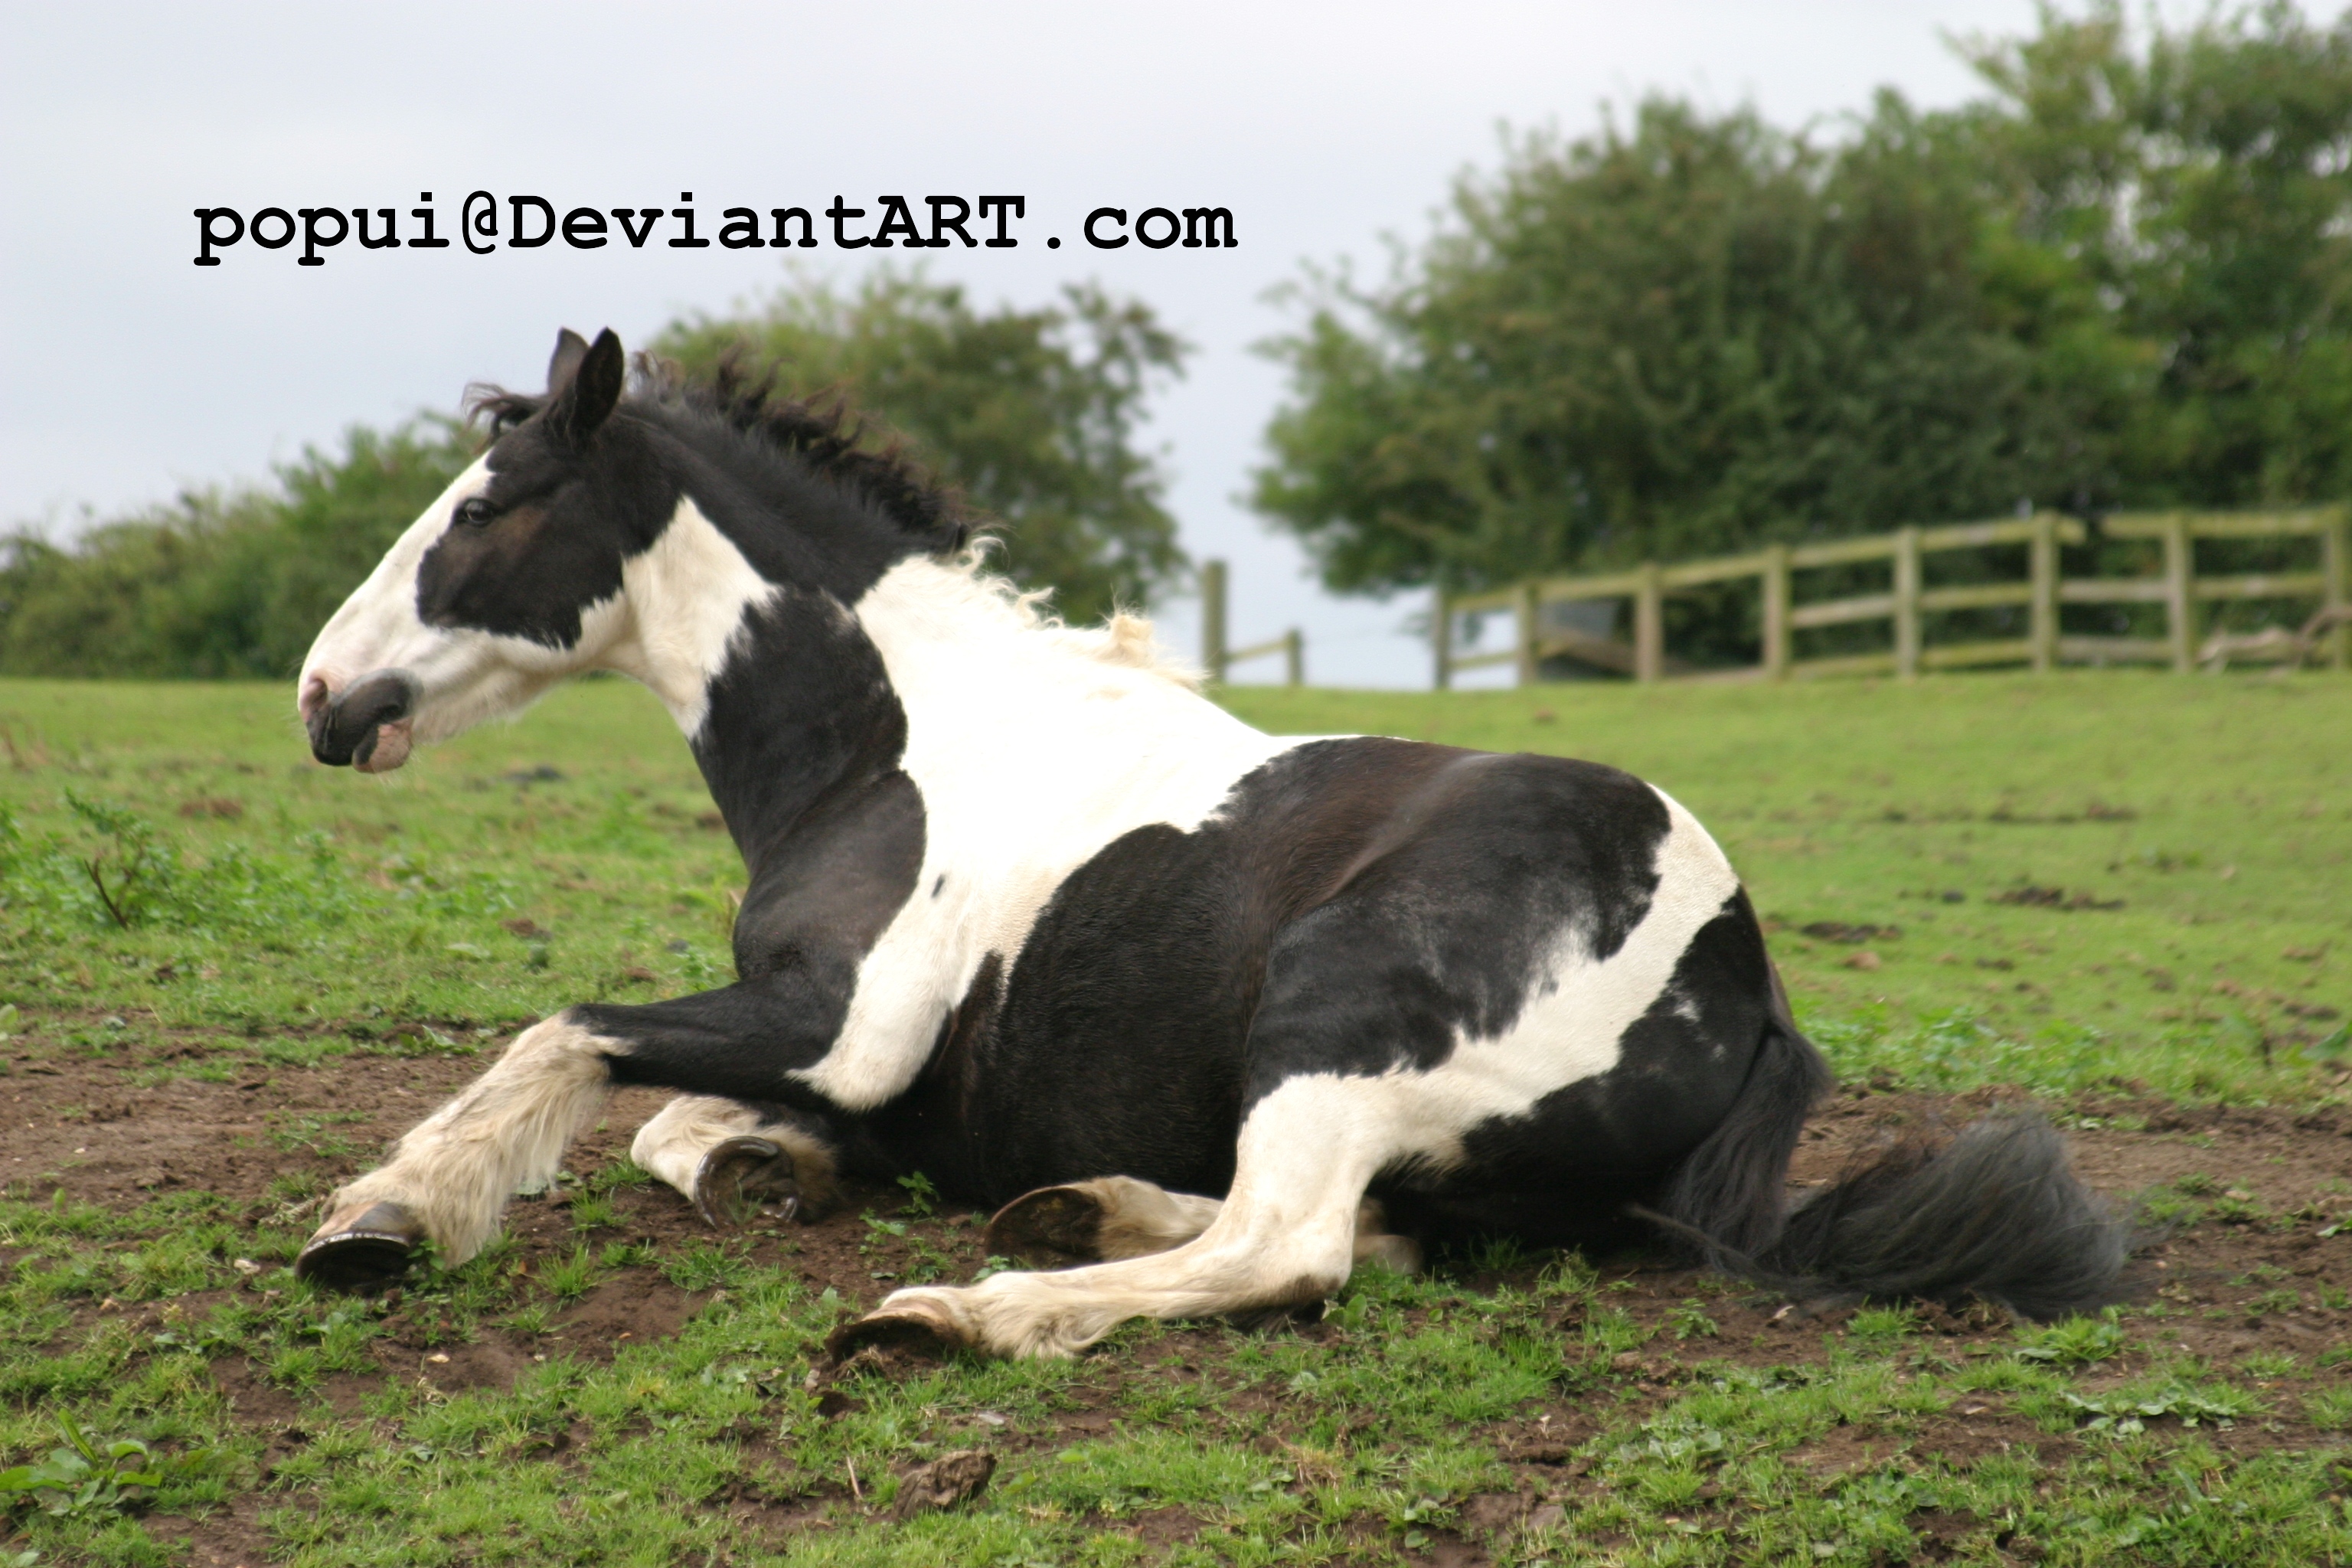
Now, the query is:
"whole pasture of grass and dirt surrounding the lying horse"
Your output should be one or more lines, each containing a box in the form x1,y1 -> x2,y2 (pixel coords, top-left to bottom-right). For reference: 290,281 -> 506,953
0,672 -> 2352,1568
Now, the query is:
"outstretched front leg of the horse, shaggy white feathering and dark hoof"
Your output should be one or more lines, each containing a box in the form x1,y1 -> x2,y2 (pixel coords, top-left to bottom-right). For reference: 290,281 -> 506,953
294,1013 -> 621,1291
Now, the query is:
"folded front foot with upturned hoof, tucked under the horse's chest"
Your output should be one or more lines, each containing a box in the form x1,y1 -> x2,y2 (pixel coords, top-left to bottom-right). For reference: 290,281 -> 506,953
628,1096 -> 838,1227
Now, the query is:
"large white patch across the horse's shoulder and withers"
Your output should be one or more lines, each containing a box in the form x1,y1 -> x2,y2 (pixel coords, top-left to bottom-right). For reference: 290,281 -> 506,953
795,557 -> 1305,1109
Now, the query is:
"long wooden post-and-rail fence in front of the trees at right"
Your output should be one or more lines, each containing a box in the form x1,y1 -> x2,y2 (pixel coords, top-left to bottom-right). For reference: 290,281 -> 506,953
1432,505 -> 2352,689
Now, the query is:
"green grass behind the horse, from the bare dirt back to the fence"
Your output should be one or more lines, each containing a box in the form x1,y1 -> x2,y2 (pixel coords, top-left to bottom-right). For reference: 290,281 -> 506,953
0,672 -> 2352,1098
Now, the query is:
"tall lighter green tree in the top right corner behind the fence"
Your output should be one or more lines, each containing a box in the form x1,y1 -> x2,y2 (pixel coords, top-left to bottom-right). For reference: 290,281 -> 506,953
1966,0 -> 2352,505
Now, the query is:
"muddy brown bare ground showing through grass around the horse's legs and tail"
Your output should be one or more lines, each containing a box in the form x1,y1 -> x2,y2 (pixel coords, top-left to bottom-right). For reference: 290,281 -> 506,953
0,1034 -> 2352,1568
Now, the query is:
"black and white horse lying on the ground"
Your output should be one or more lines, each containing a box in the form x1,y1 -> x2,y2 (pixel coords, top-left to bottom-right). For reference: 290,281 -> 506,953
299,332 -> 2124,1354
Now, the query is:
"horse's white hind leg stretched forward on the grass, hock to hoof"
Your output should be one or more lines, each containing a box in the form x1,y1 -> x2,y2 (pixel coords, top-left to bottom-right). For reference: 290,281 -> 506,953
840,1074 -> 1411,1357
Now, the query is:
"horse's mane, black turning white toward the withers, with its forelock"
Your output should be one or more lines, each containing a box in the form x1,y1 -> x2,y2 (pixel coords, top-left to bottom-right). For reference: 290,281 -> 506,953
466,348 -> 1200,687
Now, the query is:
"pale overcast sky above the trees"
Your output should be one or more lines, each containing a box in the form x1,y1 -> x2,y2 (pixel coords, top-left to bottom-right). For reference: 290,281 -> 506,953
0,0 -> 2116,687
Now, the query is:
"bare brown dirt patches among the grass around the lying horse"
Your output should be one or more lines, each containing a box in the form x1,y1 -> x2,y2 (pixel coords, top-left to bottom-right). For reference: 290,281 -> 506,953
0,1032 -> 2352,1566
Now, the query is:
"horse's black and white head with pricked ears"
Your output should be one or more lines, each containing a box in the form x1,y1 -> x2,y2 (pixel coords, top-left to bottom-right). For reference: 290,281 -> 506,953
299,332 -> 675,773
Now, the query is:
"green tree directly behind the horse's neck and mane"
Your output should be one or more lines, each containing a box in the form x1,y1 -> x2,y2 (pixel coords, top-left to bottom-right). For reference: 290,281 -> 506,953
654,270 -> 1185,621
